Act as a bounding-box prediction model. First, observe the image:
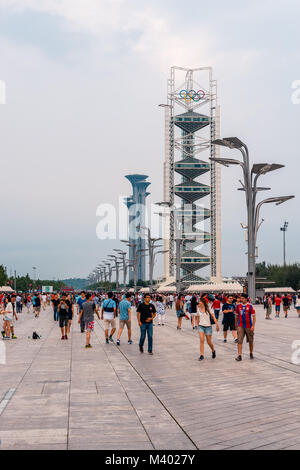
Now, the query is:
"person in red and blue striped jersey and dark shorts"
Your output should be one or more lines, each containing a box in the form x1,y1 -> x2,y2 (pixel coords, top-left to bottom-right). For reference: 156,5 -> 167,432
235,294 -> 256,362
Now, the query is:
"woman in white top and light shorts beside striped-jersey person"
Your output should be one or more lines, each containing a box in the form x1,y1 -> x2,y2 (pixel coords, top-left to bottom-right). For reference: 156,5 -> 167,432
198,298 -> 220,361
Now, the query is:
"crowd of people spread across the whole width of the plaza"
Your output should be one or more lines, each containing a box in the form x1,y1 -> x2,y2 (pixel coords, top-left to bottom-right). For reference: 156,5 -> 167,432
0,292 -> 300,362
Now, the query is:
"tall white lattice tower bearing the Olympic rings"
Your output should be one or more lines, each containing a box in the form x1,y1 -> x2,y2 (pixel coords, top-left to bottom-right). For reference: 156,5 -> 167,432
163,67 -> 221,283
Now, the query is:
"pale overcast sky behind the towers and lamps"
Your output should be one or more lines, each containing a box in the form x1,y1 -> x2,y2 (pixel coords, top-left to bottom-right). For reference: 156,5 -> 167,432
0,0 -> 300,279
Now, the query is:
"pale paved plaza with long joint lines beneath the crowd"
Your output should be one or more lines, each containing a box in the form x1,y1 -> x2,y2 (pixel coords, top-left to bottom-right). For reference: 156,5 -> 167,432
0,307 -> 300,450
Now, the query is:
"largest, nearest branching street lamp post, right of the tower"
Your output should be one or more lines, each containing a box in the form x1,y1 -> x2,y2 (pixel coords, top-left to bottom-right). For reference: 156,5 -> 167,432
211,137 -> 294,301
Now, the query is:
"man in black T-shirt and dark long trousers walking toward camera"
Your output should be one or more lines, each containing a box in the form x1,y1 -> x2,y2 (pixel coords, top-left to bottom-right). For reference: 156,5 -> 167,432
137,294 -> 156,356
